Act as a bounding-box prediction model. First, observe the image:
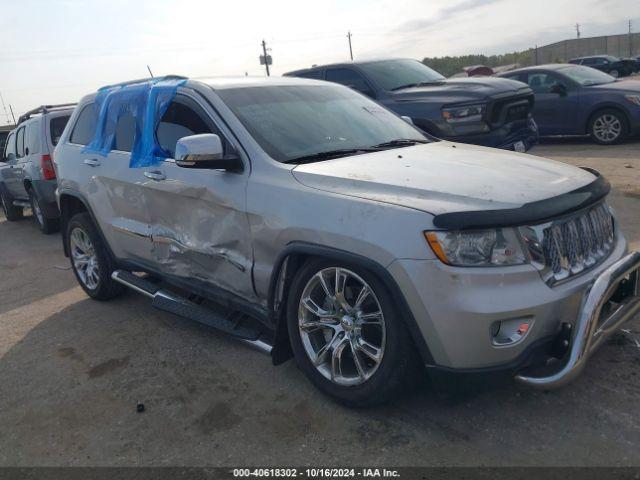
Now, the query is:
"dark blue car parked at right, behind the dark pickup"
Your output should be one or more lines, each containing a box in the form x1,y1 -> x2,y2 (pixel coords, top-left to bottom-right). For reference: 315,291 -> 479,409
500,64 -> 640,145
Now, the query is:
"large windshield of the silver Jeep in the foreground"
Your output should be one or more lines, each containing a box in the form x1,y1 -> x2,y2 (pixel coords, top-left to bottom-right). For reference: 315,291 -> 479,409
216,84 -> 427,162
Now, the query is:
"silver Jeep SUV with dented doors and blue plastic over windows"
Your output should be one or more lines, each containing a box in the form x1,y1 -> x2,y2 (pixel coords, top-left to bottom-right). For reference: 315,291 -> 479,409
54,77 -> 640,405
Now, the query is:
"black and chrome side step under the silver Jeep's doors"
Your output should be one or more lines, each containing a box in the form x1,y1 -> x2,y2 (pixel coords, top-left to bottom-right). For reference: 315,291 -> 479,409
111,270 -> 271,353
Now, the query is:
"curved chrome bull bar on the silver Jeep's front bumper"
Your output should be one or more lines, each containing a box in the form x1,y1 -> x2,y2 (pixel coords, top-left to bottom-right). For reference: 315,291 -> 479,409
516,252 -> 640,390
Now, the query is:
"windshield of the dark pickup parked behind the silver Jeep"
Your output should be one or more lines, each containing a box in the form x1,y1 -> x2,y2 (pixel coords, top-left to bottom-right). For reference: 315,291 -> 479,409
359,60 -> 445,90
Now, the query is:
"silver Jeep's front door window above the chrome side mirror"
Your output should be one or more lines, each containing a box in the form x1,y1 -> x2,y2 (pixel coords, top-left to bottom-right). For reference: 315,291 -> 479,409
156,96 -> 229,158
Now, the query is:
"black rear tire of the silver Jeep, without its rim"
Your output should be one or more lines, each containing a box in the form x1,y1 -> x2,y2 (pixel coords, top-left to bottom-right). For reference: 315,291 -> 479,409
64,213 -> 125,301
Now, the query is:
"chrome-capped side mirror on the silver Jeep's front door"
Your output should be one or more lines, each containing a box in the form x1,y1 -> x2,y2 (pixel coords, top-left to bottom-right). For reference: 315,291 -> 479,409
175,133 -> 243,171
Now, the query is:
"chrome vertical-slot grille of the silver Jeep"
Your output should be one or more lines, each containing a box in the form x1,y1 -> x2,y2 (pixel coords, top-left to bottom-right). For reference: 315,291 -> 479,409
542,203 -> 614,281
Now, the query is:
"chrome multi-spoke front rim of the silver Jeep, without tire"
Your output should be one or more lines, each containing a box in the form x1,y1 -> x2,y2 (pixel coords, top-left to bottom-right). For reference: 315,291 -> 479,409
298,267 -> 386,386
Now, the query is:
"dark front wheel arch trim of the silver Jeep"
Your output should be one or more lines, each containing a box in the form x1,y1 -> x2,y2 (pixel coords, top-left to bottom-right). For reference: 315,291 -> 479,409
268,242 -> 434,365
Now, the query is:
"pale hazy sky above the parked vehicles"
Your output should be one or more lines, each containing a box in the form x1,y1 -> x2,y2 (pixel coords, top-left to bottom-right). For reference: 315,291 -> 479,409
0,0 -> 640,123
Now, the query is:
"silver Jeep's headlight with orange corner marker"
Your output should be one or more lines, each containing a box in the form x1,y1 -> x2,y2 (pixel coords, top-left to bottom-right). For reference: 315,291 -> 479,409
425,228 -> 527,267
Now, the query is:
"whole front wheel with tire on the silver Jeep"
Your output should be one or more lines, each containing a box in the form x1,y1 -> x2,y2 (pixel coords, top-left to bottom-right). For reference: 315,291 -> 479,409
287,260 -> 419,407
